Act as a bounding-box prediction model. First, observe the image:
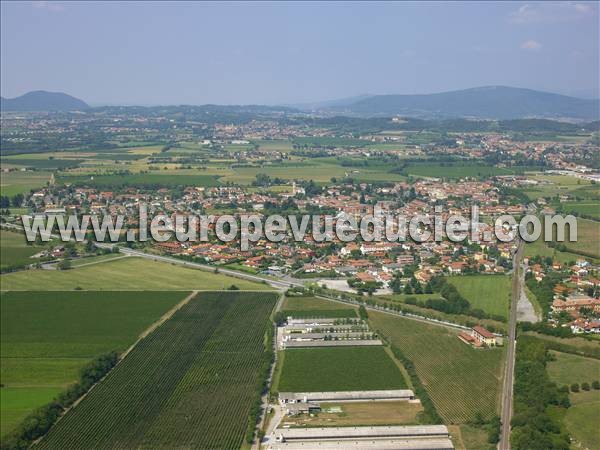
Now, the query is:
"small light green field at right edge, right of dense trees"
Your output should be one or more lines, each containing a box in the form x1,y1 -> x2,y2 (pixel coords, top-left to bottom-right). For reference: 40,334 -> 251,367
546,351 -> 600,386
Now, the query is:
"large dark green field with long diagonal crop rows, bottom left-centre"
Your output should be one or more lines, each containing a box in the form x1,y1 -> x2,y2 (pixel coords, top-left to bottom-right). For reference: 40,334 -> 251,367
38,292 -> 277,450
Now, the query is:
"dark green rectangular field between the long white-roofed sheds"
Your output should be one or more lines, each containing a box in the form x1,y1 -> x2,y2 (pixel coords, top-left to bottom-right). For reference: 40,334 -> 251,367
277,347 -> 407,392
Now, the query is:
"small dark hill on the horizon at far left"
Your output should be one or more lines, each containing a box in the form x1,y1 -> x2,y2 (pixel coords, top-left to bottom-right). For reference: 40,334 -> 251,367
0,91 -> 89,111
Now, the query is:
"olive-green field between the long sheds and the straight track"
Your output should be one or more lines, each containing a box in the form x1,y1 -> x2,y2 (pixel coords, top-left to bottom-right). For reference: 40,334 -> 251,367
369,312 -> 504,424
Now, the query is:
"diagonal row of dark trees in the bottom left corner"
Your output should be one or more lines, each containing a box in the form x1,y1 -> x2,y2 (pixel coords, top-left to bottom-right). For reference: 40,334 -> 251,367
2,352 -> 119,450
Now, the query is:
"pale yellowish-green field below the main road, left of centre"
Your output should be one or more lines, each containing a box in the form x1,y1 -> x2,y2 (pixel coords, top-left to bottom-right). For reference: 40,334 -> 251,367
0,257 -> 270,291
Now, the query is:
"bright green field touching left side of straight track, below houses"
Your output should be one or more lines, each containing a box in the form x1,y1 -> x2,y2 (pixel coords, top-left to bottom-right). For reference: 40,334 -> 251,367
448,275 -> 511,319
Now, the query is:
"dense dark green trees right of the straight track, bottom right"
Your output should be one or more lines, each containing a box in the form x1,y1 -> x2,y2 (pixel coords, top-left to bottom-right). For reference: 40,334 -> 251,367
511,336 -> 571,450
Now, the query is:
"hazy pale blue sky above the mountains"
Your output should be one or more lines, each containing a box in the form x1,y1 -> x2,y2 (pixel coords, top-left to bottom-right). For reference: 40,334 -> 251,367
0,1 -> 600,105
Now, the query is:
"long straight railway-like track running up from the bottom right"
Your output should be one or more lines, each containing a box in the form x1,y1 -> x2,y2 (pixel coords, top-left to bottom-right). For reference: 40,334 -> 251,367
498,241 -> 524,450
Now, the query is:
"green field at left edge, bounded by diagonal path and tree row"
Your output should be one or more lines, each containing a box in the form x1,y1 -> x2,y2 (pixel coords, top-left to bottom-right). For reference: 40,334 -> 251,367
0,292 -> 187,435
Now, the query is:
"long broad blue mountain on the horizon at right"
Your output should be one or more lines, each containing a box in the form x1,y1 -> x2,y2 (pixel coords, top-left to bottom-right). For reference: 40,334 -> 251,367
312,86 -> 600,120
